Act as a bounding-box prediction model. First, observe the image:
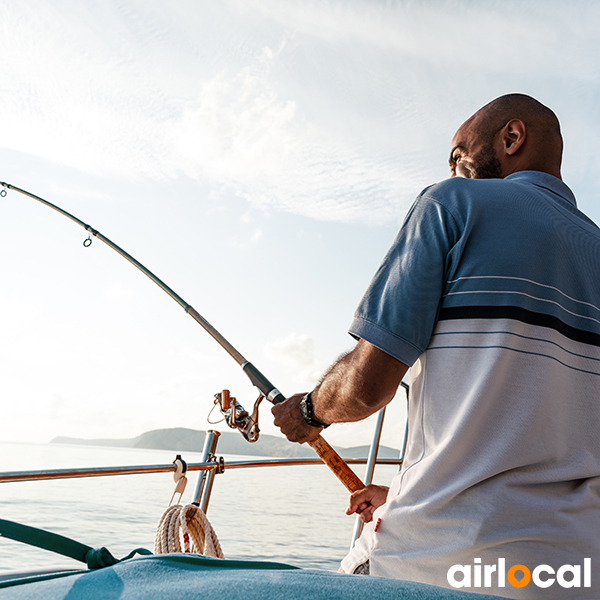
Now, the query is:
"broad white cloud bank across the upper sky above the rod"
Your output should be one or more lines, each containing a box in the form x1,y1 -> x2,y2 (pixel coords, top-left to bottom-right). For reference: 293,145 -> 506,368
0,0 -> 600,224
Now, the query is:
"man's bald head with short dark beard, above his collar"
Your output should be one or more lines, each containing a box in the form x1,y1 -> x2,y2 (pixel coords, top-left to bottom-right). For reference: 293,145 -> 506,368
450,94 -> 563,179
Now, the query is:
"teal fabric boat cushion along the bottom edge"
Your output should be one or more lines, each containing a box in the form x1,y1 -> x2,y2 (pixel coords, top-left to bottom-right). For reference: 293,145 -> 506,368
0,554 -> 510,600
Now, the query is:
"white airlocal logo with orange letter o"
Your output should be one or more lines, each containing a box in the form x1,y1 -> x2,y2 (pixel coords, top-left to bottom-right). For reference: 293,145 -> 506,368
446,558 -> 592,588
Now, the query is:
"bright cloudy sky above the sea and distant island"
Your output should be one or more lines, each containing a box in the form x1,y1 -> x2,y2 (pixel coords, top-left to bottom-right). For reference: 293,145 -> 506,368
0,0 -> 600,447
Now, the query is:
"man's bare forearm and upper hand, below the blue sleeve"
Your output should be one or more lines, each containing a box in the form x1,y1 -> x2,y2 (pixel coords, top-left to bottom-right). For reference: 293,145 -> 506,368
271,340 -> 408,444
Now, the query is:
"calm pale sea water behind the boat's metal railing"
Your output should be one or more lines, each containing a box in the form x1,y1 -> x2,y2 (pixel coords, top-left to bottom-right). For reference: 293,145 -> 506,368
0,442 -> 404,574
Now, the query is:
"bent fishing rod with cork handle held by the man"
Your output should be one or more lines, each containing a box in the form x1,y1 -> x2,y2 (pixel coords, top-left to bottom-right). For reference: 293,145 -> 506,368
0,181 -> 365,492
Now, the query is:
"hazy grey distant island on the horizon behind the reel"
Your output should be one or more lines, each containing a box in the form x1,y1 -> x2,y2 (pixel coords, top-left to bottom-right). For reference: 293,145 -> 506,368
50,427 -> 400,459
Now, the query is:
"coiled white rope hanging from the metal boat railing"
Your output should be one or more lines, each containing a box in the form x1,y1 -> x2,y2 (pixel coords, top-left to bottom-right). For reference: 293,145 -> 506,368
154,504 -> 224,558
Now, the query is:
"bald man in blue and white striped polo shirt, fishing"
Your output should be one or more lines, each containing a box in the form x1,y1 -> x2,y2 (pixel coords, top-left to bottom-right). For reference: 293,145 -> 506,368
272,94 -> 600,599
